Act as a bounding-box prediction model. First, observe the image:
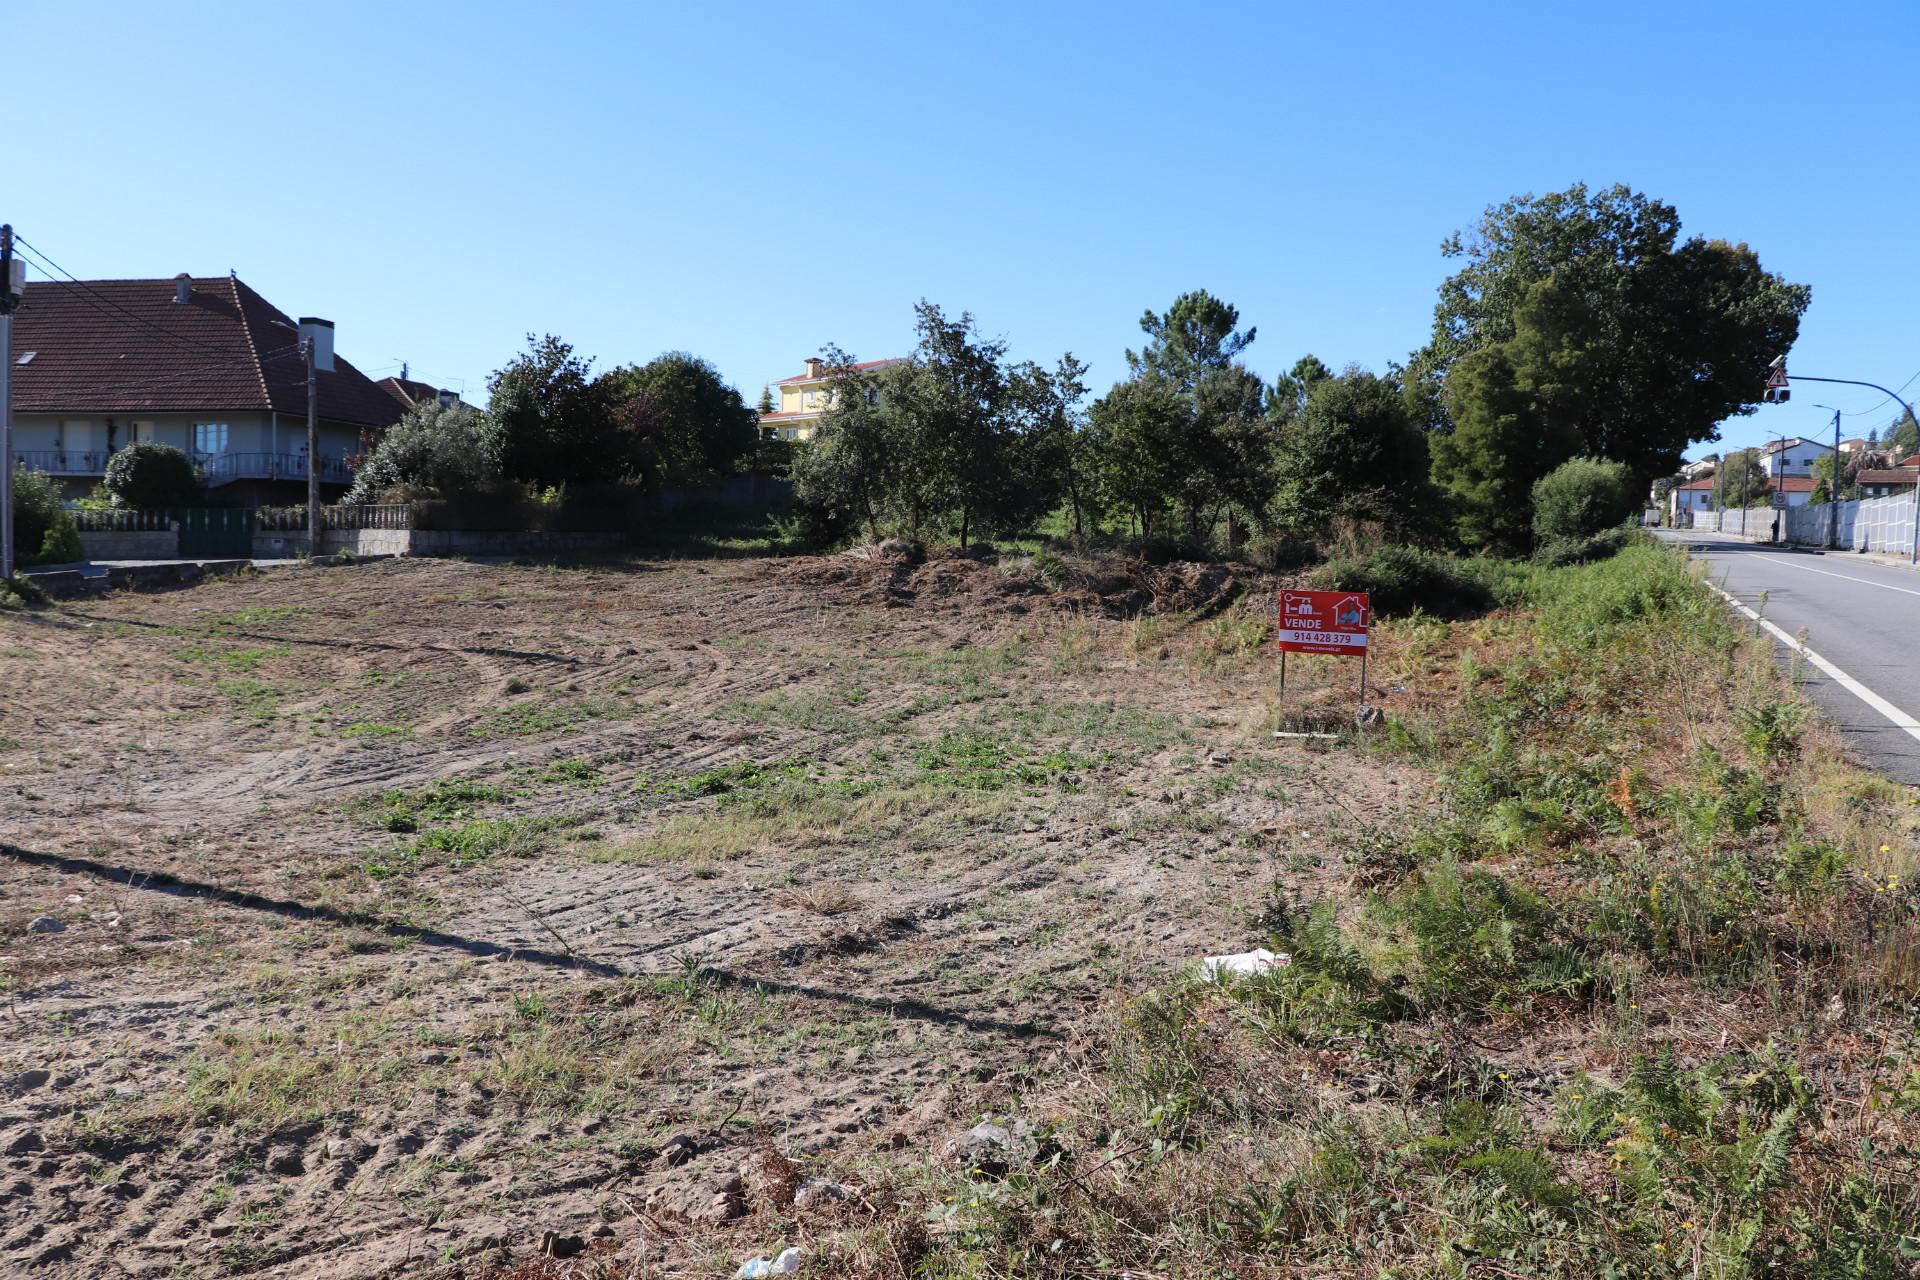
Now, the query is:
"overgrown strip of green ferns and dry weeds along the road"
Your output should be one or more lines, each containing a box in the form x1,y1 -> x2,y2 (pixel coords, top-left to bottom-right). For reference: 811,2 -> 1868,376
879,547 -> 1920,1278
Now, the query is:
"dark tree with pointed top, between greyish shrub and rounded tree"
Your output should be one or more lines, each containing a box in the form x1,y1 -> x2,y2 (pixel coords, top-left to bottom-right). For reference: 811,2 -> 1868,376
488,334 -> 633,489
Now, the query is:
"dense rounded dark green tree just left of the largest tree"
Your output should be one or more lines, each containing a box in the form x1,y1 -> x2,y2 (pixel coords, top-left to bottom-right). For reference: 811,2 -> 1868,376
1273,367 -> 1432,535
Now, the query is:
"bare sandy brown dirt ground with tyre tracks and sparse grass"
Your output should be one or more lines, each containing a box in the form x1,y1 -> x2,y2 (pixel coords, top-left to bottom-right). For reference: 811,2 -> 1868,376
0,555 -> 1423,1276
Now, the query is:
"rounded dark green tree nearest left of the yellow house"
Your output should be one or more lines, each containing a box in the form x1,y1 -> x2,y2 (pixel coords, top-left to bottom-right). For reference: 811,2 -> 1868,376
599,351 -> 758,486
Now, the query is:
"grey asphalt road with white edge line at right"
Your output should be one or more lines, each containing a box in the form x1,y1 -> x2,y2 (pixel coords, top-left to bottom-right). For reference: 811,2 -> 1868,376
1659,530 -> 1920,785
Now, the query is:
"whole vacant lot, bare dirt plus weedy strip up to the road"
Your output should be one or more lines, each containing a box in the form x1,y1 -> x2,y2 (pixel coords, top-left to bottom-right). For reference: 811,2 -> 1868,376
0,551 -> 1920,1276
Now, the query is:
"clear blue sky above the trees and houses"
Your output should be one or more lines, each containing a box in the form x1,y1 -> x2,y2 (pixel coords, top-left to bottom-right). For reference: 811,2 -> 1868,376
15,0 -> 1920,460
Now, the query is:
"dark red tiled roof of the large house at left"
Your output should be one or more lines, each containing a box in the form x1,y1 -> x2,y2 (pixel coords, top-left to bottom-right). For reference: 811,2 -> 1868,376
13,276 -> 401,426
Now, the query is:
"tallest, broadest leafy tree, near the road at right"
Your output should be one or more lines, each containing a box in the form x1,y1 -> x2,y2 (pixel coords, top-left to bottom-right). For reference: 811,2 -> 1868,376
1407,184 -> 1809,487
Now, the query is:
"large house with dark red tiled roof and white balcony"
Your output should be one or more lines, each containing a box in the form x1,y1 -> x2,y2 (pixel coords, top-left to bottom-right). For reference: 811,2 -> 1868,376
13,274 -> 401,505
